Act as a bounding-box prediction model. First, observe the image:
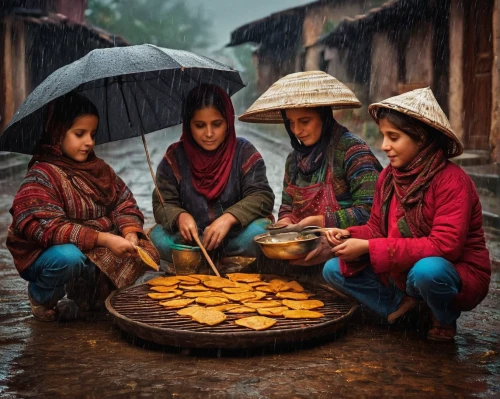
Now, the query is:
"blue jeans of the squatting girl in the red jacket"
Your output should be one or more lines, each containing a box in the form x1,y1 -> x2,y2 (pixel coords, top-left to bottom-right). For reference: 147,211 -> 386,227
323,257 -> 461,324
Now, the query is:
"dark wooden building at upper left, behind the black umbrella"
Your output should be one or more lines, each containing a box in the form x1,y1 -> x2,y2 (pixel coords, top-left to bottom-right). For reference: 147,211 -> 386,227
0,0 -> 128,131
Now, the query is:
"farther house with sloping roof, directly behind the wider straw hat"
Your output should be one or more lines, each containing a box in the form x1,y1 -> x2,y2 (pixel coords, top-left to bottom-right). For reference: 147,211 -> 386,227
228,0 -> 381,93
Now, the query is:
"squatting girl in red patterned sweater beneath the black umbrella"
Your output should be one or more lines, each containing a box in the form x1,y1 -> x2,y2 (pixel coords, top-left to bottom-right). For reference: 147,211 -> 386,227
7,93 -> 159,321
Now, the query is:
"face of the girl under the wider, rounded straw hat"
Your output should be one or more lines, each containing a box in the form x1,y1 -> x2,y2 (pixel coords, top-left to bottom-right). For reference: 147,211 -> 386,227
285,108 -> 323,147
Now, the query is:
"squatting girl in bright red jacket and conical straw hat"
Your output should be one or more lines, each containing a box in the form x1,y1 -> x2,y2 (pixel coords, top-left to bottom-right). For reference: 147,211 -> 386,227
320,88 -> 491,341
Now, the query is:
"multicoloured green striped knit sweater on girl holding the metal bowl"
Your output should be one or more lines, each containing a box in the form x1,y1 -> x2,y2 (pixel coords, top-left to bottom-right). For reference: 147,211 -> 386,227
278,132 -> 382,229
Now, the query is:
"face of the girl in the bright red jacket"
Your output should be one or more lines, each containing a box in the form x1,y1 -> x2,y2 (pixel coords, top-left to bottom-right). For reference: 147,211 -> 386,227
379,119 -> 422,169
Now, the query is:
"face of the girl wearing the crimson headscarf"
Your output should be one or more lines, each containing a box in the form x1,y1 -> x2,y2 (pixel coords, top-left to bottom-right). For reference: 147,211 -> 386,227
189,107 -> 227,151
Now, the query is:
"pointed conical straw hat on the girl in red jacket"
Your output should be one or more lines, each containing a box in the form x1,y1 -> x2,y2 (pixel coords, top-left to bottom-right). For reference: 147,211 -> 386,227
368,87 -> 464,158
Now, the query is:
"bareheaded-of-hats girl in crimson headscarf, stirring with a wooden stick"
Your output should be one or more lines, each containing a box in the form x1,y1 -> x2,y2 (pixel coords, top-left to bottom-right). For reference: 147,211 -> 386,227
150,85 -> 274,268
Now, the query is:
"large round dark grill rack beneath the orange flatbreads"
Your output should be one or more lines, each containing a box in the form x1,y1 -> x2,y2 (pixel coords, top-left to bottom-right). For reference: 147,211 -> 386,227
106,282 -> 357,349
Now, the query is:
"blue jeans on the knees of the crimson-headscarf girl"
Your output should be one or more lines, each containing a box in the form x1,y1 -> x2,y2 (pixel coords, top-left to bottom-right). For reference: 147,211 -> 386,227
149,218 -> 271,262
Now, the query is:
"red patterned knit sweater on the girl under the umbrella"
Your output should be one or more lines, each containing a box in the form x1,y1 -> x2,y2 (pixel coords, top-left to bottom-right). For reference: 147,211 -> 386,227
7,162 -> 159,288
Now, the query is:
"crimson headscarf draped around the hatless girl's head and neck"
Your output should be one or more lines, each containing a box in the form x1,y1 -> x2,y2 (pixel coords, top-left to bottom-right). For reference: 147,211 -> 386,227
181,86 -> 236,201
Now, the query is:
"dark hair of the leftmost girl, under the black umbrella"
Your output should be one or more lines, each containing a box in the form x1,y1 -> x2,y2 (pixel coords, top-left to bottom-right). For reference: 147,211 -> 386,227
42,92 -> 99,145
